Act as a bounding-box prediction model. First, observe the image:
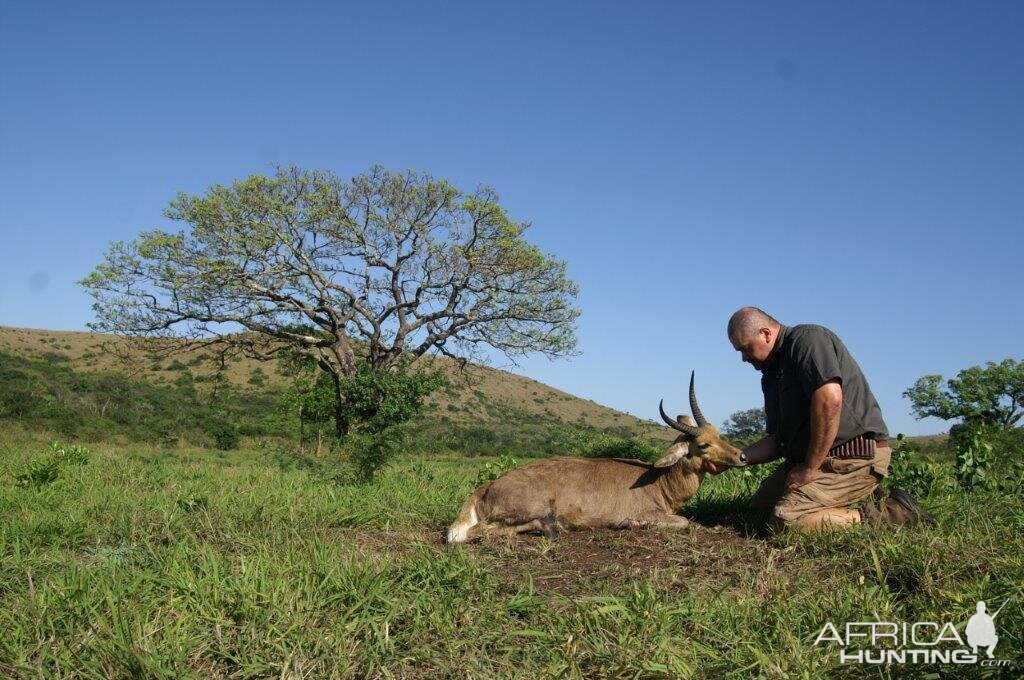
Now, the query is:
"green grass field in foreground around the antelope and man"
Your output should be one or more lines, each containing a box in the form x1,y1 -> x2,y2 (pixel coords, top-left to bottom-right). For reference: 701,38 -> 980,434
0,431 -> 1024,678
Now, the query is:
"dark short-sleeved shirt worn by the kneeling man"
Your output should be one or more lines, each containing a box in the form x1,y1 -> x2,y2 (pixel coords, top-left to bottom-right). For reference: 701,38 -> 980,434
761,324 -> 889,462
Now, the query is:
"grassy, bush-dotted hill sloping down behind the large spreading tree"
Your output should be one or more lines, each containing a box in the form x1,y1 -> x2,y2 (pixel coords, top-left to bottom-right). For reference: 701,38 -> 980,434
0,327 -> 672,456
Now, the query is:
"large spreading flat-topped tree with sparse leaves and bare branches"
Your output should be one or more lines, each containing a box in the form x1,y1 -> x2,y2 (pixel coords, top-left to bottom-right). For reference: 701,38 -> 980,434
81,166 -> 580,436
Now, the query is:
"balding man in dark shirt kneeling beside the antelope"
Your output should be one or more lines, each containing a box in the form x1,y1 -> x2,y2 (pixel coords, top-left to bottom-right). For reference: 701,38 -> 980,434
720,307 -> 935,530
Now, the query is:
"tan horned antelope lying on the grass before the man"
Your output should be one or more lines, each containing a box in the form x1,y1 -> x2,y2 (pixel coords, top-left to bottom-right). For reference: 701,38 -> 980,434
447,374 -> 746,543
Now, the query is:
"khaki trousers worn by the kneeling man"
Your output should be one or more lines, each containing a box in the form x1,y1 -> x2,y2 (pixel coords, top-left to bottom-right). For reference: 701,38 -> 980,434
751,447 -> 892,525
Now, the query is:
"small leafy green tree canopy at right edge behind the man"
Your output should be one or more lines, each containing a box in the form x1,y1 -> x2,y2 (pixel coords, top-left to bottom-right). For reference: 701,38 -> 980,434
903,358 -> 1024,429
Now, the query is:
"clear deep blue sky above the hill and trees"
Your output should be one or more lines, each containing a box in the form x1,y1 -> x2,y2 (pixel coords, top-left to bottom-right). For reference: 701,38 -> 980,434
0,0 -> 1024,433
